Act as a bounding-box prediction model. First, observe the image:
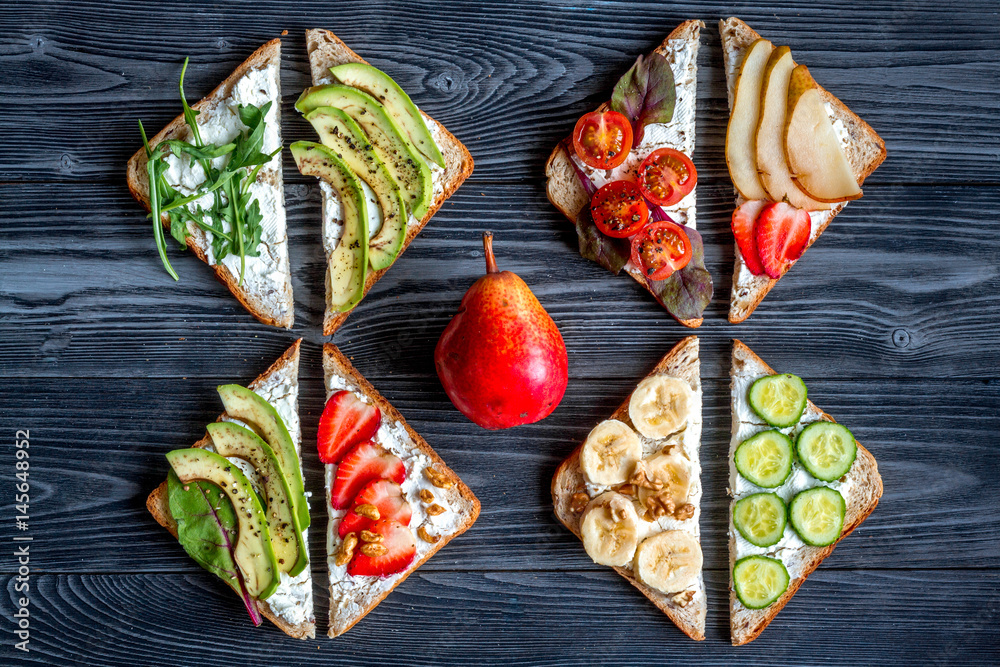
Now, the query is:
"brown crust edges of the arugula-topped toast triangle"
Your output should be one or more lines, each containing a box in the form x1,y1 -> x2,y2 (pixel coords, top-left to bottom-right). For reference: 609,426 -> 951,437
125,39 -> 295,329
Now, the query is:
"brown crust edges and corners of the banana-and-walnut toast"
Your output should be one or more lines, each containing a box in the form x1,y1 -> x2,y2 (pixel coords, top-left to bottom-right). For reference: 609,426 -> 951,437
552,336 -> 707,641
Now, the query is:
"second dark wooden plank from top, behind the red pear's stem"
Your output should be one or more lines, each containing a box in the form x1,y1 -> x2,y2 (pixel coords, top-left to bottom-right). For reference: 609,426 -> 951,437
0,180 -> 1000,378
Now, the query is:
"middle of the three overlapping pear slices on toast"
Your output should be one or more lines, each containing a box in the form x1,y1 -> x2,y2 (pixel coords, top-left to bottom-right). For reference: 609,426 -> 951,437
754,46 -> 831,211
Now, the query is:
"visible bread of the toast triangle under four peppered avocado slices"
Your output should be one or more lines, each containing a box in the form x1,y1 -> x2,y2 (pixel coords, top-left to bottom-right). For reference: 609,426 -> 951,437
306,28 -> 473,336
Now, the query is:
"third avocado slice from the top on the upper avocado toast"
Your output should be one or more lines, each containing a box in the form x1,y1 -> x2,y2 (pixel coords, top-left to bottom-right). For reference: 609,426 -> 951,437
305,107 -> 406,271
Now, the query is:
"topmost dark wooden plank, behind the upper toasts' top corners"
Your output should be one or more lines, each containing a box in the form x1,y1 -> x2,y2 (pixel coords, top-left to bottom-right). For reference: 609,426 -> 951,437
0,0 -> 1000,184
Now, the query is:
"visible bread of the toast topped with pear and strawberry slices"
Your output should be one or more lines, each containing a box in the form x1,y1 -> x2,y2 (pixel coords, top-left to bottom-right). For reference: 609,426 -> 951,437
719,17 -> 886,324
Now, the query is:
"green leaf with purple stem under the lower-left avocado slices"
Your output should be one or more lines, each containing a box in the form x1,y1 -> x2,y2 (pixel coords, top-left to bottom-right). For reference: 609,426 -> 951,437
167,469 -> 263,626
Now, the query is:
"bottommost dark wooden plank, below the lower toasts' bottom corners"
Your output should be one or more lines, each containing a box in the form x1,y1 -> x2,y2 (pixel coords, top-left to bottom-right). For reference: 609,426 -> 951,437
0,569 -> 1000,667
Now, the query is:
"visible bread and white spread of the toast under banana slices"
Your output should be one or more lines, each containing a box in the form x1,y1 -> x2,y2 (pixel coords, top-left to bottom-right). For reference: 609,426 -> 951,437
552,336 -> 707,641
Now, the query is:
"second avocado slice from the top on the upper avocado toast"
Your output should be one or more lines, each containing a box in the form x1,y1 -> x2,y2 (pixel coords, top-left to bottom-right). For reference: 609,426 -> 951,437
295,84 -> 432,220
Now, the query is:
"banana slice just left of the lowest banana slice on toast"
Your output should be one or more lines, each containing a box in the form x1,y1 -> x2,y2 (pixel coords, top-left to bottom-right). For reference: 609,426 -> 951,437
580,491 -> 639,566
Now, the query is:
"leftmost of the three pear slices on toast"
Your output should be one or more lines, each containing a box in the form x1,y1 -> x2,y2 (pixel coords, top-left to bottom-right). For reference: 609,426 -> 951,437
726,39 -> 774,200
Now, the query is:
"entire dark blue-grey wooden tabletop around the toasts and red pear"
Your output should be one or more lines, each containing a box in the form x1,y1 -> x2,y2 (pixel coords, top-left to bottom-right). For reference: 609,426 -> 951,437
0,0 -> 1000,665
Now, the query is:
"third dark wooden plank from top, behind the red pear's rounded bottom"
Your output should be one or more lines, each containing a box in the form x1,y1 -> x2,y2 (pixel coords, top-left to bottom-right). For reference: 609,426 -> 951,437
0,376 -> 1000,572
